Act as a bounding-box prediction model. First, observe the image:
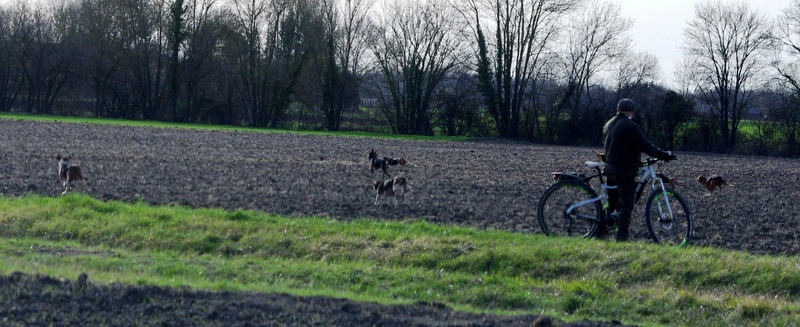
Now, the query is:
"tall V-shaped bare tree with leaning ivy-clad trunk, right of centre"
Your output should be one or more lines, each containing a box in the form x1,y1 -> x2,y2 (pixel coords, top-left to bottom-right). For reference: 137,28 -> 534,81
459,0 -> 579,138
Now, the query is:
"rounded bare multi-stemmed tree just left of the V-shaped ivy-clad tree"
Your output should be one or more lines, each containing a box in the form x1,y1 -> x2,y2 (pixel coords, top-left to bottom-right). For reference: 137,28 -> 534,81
371,0 -> 459,134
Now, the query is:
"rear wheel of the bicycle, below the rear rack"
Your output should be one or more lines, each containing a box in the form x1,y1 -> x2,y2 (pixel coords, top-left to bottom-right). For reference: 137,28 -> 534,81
536,180 -> 603,237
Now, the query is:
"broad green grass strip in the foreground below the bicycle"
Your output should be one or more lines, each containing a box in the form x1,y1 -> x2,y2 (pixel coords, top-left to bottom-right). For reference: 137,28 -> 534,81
0,195 -> 800,326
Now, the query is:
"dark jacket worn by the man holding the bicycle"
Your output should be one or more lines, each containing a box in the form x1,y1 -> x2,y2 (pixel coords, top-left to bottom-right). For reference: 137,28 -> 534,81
603,113 -> 670,176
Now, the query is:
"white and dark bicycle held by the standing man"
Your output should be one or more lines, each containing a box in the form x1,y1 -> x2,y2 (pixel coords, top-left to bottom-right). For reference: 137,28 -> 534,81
537,154 -> 692,247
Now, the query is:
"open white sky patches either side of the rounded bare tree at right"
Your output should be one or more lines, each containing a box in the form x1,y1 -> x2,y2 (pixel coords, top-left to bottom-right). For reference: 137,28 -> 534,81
612,0 -> 791,86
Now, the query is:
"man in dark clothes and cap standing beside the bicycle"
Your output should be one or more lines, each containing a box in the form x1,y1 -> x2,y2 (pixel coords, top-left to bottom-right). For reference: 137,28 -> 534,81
600,98 -> 675,242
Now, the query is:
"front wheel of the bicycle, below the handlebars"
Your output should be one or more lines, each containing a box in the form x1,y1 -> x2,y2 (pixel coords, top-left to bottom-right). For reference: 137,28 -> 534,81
644,188 -> 692,247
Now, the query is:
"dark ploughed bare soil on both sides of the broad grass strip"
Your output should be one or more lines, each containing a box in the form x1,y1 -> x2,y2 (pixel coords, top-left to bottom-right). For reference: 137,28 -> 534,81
0,119 -> 800,326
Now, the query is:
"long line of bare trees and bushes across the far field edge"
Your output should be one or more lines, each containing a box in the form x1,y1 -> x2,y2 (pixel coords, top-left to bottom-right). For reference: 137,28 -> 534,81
0,0 -> 800,156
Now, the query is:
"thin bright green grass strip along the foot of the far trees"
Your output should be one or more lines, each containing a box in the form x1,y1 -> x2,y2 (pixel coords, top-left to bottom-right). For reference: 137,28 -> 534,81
0,113 -> 467,141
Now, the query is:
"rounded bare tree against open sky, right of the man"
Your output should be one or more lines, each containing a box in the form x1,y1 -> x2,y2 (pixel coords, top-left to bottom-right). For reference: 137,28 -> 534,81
683,0 -> 772,149
